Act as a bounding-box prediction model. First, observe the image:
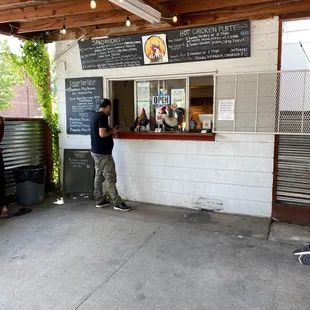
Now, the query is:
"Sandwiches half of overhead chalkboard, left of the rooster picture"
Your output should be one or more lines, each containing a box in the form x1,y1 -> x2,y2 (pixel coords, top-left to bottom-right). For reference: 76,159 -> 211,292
79,35 -> 143,70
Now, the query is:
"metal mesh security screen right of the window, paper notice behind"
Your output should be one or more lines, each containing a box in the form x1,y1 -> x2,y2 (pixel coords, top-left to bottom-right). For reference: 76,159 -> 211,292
213,71 -> 310,135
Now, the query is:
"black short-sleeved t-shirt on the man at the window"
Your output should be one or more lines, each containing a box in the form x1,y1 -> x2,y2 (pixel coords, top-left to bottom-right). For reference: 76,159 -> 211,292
90,112 -> 114,155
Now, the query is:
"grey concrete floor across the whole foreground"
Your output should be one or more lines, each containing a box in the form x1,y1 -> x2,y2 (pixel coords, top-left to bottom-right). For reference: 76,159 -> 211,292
0,200 -> 310,310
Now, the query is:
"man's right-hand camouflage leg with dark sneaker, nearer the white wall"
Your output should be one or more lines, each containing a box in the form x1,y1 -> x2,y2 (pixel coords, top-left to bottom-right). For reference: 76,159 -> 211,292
103,155 -> 130,211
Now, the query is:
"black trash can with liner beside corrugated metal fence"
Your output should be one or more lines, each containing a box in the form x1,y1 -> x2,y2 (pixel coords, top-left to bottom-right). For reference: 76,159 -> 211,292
13,166 -> 46,206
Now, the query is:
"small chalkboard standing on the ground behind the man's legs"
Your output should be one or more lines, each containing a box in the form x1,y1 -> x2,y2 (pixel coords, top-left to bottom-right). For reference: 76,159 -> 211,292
63,149 -> 95,196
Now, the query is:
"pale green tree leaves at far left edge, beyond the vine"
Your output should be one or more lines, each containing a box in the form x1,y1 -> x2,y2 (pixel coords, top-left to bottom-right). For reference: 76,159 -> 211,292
0,40 -> 23,111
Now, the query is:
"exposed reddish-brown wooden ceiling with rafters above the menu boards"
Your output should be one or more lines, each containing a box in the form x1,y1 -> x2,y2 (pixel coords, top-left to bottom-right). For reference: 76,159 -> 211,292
0,0 -> 310,40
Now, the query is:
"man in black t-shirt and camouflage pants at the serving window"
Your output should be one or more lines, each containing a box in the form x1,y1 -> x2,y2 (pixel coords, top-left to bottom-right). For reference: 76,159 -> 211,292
90,99 -> 131,211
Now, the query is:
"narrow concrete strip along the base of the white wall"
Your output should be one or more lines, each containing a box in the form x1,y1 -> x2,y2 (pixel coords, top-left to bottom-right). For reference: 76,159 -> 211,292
59,198 -> 271,239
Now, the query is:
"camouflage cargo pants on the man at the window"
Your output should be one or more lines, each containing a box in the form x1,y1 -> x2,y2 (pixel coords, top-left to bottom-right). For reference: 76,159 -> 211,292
92,153 -> 123,206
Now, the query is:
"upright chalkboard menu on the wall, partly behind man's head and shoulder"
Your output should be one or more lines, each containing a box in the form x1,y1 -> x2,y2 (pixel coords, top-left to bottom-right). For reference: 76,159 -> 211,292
65,77 -> 103,135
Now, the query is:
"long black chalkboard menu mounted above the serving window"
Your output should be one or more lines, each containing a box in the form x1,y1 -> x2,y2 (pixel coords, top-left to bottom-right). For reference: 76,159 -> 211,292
79,21 -> 251,70
